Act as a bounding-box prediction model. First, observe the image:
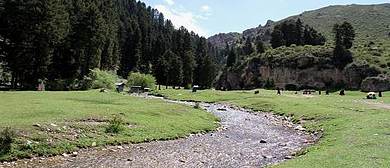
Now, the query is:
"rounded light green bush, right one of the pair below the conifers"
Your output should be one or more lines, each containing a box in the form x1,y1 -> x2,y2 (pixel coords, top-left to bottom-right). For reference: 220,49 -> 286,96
128,72 -> 156,89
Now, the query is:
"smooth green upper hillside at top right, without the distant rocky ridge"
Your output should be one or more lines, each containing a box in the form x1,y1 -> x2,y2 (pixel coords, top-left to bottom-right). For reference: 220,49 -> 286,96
287,4 -> 390,43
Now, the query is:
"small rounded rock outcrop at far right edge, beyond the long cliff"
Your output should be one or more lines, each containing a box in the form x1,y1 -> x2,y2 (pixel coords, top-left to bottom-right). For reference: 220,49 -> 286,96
361,75 -> 390,92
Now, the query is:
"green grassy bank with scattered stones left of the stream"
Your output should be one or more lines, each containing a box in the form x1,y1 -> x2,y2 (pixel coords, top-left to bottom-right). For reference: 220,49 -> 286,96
0,90 -> 218,160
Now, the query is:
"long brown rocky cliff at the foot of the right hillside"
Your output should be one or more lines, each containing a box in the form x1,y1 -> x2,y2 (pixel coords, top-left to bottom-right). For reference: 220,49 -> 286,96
216,51 -> 385,90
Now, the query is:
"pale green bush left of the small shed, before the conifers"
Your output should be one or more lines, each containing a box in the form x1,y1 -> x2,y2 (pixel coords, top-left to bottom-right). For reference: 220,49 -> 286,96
82,69 -> 118,90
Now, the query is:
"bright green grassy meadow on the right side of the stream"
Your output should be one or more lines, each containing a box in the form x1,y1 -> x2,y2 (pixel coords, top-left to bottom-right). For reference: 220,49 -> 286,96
154,90 -> 390,168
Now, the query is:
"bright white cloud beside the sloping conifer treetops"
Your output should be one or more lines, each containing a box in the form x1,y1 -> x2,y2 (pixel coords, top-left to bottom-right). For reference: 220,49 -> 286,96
154,5 -> 207,36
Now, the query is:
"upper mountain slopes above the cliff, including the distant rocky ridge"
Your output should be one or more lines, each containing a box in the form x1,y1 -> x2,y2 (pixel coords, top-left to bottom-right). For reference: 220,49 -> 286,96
208,3 -> 390,49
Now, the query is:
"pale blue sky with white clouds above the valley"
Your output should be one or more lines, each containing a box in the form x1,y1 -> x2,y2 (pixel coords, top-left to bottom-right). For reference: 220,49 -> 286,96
141,0 -> 389,37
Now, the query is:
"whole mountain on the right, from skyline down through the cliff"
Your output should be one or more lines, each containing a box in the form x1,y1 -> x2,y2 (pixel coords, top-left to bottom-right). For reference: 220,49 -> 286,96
212,4 -> 390,91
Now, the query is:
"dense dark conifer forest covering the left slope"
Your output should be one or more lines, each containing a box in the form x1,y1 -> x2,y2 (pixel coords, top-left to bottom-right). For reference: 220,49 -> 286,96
0,0 -> 217,89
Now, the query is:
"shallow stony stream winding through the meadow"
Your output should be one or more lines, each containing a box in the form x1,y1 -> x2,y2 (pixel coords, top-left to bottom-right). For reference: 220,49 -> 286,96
0,95 -> 316,168
